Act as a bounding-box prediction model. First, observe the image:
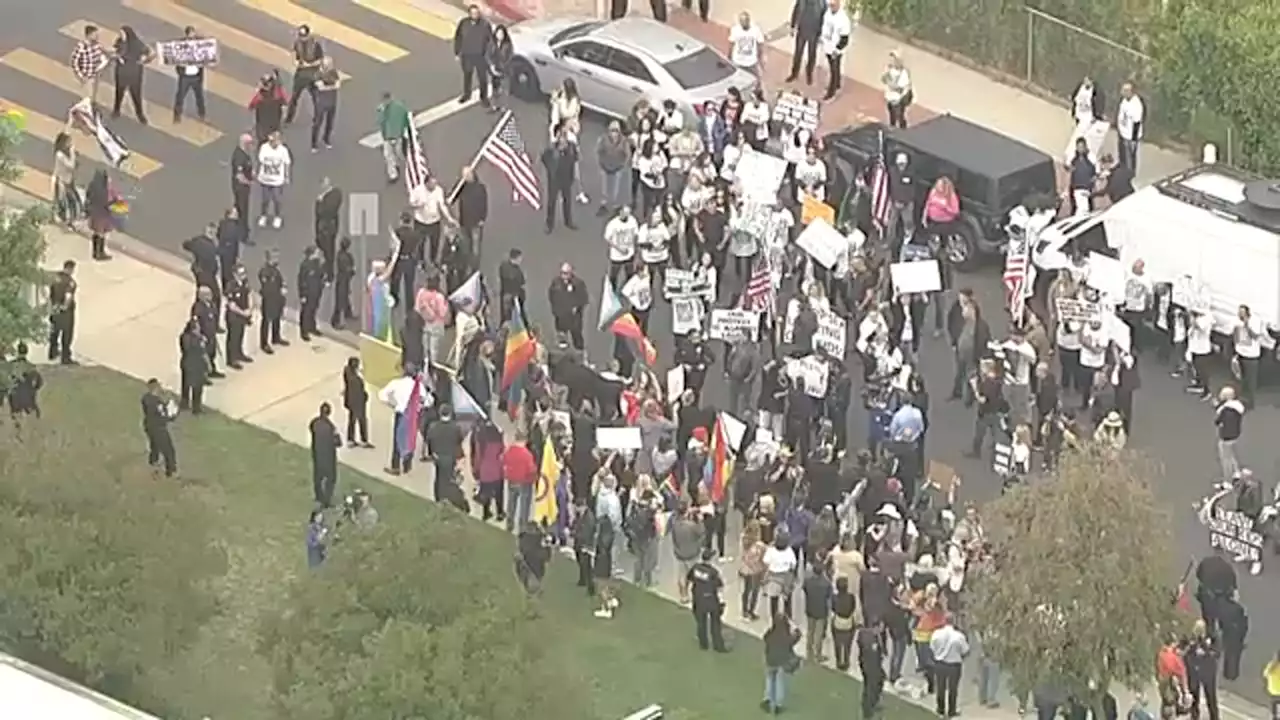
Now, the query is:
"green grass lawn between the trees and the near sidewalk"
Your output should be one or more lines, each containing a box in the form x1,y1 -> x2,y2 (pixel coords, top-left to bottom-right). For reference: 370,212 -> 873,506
22,368 -> 933,720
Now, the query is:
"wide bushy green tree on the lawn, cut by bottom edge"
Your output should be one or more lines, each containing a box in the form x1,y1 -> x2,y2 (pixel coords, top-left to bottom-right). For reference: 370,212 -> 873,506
261,511 -> 589,720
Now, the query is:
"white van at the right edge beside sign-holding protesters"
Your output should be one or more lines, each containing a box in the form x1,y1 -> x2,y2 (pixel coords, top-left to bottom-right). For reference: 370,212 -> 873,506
1032,165 -> 1280,334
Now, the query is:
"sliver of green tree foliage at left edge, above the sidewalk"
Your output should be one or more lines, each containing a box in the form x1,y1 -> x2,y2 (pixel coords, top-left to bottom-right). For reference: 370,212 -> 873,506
0,110 -> 49,355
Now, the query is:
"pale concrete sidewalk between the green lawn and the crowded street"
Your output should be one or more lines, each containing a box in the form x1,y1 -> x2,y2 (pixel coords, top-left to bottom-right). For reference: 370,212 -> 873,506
3,183 -> 1265,720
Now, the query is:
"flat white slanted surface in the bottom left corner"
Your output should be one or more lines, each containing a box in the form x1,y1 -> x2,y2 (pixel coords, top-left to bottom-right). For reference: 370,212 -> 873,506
0,653 -> 159,720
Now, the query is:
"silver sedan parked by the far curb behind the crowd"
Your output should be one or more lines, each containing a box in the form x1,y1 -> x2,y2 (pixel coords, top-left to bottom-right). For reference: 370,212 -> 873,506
511,17 -> 756,119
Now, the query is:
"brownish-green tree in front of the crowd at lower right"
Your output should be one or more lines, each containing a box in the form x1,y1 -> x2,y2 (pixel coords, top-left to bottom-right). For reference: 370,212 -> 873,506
965,446 -> 1176,703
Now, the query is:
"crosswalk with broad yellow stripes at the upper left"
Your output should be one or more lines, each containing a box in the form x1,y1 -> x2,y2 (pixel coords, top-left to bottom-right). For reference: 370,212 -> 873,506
0,0 -> 465,200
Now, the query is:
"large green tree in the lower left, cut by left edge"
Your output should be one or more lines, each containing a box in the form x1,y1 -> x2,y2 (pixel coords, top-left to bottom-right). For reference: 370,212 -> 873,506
0,392 -> 227,707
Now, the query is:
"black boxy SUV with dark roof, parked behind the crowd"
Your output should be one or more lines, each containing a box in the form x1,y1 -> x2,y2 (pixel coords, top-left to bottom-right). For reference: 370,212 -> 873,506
824,115 -> 1057,270
